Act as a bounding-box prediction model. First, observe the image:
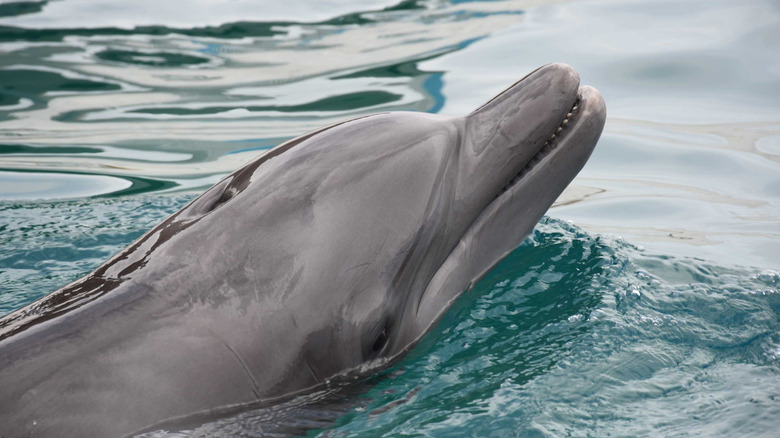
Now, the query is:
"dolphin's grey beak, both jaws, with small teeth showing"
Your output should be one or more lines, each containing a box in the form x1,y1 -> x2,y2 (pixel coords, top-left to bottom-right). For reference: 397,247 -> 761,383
389,63 -> 606,362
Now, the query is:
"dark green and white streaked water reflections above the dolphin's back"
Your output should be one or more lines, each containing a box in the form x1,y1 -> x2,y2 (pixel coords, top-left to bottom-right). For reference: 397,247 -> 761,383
0,1 -> 523,199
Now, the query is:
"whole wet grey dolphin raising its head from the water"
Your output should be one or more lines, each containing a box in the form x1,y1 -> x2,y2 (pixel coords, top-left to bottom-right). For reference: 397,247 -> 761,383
0,64 -> 606,437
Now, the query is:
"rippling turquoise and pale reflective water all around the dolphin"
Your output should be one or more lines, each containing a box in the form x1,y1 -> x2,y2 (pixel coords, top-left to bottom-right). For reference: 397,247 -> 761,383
0,0 -> 780,437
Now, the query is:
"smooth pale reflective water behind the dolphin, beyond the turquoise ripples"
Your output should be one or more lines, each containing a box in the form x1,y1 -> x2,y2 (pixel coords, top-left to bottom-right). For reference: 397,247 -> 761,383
0,0 -> 780,267
